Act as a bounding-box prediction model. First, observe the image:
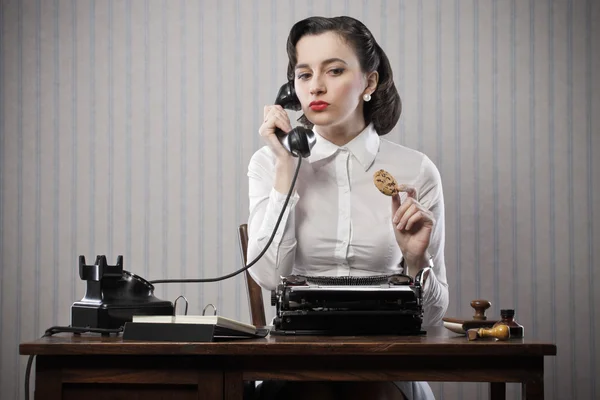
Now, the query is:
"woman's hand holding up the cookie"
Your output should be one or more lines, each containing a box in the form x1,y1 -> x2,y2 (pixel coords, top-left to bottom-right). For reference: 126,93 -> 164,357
392,185 -> 435,270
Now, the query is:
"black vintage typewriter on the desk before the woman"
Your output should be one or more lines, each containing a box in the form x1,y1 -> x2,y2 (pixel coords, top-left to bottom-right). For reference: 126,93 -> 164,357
271,270 -> 425,335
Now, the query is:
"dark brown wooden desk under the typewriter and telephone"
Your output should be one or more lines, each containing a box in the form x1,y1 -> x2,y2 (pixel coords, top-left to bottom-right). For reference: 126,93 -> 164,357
20,327 -> 556,400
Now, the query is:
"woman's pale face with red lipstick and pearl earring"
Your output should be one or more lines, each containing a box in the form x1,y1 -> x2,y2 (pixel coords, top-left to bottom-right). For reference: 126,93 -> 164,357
294,32 -> 376,134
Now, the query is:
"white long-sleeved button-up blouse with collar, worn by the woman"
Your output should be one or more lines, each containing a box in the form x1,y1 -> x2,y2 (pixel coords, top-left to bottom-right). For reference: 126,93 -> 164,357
247,124 -> 448,326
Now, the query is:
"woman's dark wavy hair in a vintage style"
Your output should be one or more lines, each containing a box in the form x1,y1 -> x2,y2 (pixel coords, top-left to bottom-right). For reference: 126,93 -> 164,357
287,16 -> 402,135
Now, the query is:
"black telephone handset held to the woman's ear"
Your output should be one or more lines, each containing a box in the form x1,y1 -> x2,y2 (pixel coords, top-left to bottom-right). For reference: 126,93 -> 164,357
275,81 -> 316,158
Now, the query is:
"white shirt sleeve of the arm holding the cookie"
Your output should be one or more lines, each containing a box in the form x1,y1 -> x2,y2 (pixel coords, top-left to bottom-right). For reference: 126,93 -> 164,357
418,156 -> 449,326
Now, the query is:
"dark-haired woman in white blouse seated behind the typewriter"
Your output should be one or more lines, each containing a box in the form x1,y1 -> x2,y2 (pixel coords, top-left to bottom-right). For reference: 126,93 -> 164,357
248,17 -> 448,399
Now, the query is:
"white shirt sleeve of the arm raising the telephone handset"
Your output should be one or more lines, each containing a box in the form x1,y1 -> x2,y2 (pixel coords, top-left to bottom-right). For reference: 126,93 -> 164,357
247,148 -> 299,290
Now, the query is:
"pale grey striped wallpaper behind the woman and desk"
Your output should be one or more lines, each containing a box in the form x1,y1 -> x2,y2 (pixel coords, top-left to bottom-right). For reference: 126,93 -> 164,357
0,0 -> 600,399
